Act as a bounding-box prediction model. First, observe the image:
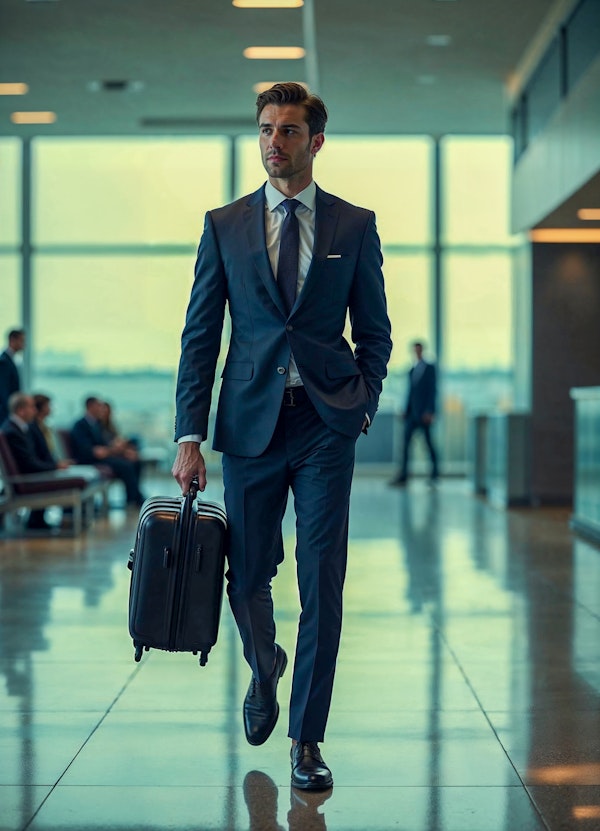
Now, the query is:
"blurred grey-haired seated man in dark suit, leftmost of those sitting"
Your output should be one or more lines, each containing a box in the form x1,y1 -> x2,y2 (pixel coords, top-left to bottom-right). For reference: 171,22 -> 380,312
0,392 -> 69,530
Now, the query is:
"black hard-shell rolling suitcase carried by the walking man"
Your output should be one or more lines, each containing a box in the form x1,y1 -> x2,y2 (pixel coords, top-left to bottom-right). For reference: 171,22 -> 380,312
129,482 -> 227,666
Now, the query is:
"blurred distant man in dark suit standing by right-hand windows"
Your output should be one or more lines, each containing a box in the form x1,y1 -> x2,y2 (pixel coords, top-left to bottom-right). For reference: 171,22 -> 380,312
390,341 -> 439,486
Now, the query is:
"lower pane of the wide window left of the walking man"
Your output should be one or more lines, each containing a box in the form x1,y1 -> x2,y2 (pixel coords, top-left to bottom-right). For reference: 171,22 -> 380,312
33,255 -> 193,447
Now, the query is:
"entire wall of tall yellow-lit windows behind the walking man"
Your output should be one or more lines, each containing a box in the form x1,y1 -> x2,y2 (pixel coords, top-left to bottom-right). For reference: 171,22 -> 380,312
10,134 -> 519,469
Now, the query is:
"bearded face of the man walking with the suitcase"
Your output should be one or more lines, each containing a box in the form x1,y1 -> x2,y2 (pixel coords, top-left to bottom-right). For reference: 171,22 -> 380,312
258,104 -> 325,184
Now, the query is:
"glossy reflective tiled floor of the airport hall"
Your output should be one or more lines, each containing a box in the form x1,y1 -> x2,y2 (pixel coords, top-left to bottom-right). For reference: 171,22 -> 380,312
0,475 -> 600,831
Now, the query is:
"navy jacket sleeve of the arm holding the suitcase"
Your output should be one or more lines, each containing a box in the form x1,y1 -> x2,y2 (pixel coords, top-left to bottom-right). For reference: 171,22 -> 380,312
175,211 -> 227,441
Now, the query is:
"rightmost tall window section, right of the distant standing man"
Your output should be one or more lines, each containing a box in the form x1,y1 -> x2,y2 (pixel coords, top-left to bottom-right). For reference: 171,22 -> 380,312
440,136 -> 519,470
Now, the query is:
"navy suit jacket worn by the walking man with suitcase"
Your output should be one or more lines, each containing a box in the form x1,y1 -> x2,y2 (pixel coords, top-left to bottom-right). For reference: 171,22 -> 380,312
175,187 -> 392,457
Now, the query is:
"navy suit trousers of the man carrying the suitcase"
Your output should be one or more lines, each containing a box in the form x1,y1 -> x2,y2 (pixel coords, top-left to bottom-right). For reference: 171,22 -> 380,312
223,389 -> 356,741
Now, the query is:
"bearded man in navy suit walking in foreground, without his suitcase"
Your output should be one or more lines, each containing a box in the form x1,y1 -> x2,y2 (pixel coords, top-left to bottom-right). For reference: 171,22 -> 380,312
173,83 -> 392,790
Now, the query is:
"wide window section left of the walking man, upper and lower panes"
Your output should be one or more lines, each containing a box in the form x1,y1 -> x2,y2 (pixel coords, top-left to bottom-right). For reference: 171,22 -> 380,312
32,137 -> 229,468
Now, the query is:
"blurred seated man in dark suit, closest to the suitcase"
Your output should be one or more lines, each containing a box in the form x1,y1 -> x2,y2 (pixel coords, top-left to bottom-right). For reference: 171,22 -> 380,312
71,396 -> 144,507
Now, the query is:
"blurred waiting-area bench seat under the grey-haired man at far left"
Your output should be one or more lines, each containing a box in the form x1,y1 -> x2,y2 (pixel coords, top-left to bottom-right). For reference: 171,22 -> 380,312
0,431 -> 110,536
